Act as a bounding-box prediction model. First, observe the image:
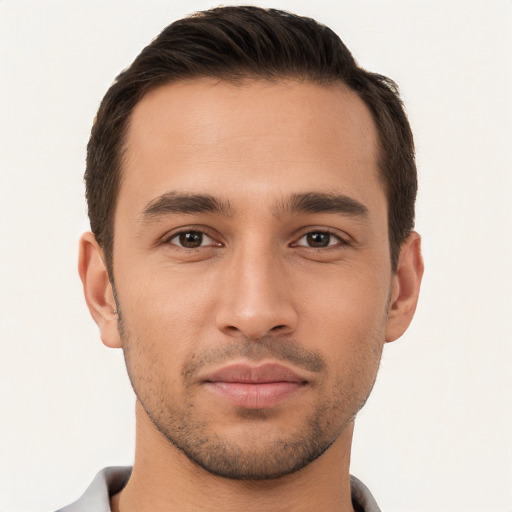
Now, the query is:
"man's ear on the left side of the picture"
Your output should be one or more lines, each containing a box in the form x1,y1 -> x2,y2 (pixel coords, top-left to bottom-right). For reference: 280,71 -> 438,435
78,232 -> 122,348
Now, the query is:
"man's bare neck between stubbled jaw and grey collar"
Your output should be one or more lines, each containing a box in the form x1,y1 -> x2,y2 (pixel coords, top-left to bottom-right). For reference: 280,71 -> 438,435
111,402 -> 353,512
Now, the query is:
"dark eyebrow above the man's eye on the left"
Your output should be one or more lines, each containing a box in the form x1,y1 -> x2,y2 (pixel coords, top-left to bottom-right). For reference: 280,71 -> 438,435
140,192 -> 232,222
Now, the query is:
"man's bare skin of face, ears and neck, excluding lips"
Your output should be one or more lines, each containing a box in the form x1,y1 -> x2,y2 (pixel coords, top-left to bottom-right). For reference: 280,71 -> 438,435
79,79 -> 423,512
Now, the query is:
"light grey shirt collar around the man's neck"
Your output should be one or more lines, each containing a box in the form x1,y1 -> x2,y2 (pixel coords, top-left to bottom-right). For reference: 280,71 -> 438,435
57,466 -> 381,512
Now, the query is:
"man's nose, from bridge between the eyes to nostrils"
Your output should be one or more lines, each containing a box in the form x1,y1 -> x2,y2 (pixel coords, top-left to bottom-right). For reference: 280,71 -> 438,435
216,246 -> 298,339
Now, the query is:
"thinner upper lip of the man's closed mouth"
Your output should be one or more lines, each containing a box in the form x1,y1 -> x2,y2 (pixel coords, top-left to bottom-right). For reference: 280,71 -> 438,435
203,363 -> 307,384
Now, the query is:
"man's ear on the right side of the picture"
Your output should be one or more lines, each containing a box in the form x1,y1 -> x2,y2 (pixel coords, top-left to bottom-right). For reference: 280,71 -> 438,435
386,231 -> 424,342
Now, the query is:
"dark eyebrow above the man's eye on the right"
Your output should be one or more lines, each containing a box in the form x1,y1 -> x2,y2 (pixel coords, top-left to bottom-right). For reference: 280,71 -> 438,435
276,192 -> 369,218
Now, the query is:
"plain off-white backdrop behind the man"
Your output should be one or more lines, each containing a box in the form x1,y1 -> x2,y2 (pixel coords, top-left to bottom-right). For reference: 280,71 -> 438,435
0,0 -> 512,512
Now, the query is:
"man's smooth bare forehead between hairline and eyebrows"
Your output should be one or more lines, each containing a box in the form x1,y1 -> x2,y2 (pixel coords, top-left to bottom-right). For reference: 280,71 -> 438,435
119,79 -> 383,214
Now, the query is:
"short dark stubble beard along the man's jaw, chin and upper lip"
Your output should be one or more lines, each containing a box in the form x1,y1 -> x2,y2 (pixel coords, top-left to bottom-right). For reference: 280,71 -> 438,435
118,304 -> 380,481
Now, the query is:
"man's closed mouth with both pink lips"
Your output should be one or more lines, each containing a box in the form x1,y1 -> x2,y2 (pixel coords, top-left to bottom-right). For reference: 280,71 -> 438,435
203,363 -> 308,409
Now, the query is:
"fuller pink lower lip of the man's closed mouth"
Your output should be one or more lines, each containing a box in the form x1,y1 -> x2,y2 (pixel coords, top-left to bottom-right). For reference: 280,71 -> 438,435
207,382 -> 304,409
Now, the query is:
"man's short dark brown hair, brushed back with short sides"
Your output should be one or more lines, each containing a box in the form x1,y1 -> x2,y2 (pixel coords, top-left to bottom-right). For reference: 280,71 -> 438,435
85,6 -> 417,279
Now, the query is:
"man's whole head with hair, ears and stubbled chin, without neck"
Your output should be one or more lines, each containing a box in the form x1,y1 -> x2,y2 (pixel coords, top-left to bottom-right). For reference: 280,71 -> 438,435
79,7 -> 423,479
